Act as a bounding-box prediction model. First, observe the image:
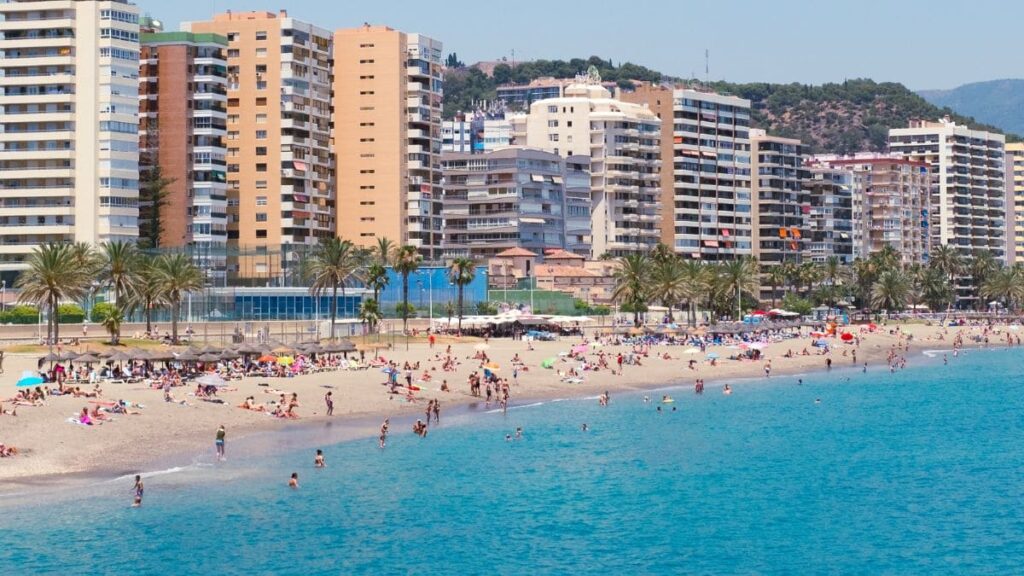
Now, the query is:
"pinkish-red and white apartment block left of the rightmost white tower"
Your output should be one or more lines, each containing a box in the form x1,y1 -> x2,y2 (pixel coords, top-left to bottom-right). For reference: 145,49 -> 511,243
814,154 -> 932,264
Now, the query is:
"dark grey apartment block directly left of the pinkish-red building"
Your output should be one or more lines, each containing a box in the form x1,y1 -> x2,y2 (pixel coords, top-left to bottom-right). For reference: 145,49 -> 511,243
804,166 -> 863,264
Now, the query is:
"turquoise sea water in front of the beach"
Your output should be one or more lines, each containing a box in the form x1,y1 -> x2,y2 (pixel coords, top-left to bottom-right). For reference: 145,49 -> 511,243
0,351 -> 1024,574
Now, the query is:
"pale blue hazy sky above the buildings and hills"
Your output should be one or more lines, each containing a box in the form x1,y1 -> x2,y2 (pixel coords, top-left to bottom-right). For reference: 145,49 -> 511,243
135,0 -> 1024,89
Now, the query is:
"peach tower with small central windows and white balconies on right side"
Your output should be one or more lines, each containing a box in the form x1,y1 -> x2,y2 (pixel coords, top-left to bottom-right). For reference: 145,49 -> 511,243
334,25 -> 443,260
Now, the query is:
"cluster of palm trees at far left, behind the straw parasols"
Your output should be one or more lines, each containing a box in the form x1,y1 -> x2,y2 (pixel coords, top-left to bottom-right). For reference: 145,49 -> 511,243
14,241 -> 204,343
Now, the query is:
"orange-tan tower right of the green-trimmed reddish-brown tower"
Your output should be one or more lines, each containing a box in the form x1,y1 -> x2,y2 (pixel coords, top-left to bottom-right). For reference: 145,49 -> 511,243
184,10 -> 335,279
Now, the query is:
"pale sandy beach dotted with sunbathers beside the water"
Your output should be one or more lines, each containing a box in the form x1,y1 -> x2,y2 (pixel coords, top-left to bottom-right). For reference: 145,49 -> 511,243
0,323 -> 1016,491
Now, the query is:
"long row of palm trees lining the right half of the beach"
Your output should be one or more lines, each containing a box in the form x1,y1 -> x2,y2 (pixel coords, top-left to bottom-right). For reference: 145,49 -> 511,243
612,244 -> 1024,323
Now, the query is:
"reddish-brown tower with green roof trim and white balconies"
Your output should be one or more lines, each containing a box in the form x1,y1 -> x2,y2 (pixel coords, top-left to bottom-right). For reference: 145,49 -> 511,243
138,17 -> 227,280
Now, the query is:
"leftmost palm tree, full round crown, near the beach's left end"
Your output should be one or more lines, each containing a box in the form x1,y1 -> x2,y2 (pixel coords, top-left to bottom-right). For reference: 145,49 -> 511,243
14,242 -> 94,342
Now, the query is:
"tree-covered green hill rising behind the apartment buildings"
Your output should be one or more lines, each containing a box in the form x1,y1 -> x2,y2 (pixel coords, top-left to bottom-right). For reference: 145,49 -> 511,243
444,56 -> 1024,154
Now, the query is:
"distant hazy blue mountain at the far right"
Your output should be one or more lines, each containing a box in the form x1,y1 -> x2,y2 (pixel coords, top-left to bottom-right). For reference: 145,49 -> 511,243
918,79 -> 1024,134
